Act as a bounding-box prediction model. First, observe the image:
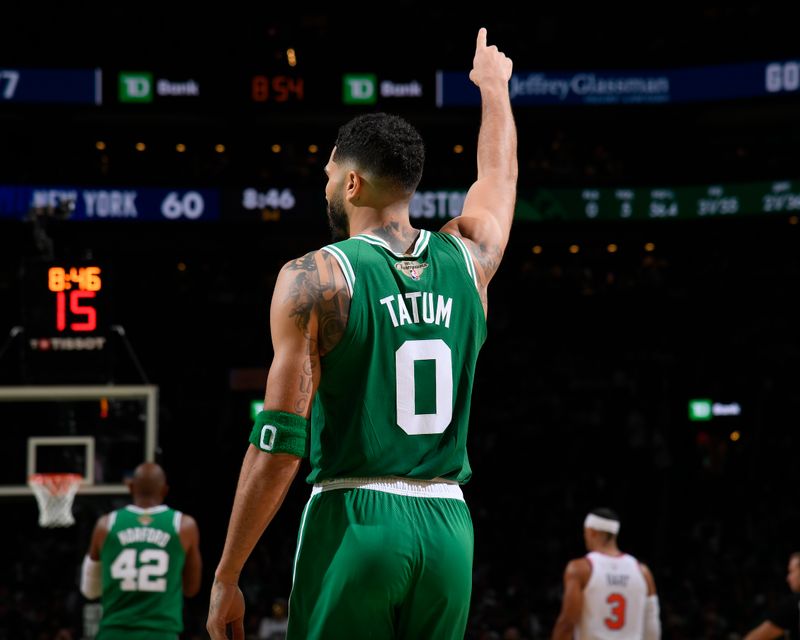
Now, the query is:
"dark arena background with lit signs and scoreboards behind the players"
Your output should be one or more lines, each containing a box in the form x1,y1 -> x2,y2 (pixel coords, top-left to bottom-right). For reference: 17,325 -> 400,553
0,2 -> 800,640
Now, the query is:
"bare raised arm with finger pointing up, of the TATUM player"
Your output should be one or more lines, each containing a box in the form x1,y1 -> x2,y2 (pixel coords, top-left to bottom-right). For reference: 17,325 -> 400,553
442,28 -> 518,288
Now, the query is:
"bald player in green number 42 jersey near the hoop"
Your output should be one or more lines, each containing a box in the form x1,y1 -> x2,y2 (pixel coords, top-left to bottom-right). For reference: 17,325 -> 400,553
81,462 -> 202,640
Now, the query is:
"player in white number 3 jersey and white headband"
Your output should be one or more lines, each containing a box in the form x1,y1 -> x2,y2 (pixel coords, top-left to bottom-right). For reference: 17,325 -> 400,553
552,508 -> 661,640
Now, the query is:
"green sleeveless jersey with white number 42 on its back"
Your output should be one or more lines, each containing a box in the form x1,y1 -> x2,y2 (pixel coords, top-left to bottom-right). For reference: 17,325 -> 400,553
100,505 -> 186,633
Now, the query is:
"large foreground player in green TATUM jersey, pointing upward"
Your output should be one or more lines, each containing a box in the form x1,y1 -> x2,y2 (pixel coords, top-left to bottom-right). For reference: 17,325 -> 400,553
207,29 -> 517,640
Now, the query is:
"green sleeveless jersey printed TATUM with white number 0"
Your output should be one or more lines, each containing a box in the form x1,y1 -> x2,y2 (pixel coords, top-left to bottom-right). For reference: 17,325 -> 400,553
308,231 -> 486,483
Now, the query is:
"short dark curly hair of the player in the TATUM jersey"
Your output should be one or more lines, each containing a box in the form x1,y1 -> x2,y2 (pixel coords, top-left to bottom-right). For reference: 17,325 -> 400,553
333,113 -> 425,192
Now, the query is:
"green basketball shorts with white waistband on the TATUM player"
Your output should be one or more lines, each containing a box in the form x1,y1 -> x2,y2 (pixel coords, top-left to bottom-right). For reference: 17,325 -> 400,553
286,478 -> 474,640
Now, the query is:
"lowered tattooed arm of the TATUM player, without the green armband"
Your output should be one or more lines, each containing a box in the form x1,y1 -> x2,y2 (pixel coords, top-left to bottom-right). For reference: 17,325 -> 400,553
206,251 -> 349,640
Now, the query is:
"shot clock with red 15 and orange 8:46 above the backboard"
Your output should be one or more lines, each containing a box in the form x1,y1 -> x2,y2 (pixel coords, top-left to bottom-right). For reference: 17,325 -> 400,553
22,261 -> 110,382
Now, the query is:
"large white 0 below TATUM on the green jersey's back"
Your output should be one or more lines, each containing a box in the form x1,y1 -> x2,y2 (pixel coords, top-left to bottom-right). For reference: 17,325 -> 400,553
395,338 -> 453,436
